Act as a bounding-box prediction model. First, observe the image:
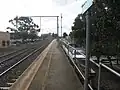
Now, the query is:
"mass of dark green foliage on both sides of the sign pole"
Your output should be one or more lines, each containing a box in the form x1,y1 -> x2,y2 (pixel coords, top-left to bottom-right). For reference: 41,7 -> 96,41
70,0 -> 120,60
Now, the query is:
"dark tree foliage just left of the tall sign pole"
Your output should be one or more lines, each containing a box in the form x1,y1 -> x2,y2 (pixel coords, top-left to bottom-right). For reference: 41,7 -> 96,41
70,14 -> 86,46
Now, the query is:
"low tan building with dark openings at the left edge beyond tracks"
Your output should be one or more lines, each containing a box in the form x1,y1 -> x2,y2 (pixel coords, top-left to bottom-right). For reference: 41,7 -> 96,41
0,31 -> 10,48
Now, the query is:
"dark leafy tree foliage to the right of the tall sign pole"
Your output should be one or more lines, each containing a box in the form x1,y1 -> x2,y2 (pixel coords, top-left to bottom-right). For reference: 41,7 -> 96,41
91,0 -> 120,61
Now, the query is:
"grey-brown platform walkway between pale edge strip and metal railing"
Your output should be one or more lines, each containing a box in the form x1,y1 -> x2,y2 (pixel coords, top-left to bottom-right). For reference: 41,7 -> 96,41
28,41 -> 83,90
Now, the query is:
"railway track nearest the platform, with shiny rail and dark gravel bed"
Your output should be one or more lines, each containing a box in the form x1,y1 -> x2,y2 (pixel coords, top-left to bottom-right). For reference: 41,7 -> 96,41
0,40 -> 51,90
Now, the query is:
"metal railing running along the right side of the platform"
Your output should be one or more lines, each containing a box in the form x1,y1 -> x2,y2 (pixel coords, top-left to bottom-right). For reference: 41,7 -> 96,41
60,40 -> 120,90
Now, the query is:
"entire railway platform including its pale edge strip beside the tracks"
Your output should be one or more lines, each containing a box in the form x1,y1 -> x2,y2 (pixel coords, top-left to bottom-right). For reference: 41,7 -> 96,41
10,40 -> 83,90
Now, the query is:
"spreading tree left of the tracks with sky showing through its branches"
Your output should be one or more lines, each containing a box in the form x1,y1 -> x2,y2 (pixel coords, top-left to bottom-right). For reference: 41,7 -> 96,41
8,17 -> 40,41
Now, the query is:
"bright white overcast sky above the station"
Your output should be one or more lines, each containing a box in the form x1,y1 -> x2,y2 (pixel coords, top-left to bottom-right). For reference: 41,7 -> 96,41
0,0 -> 85,35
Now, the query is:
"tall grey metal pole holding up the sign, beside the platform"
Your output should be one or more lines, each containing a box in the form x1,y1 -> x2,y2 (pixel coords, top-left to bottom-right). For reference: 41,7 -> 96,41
84,11 -> 90,90
